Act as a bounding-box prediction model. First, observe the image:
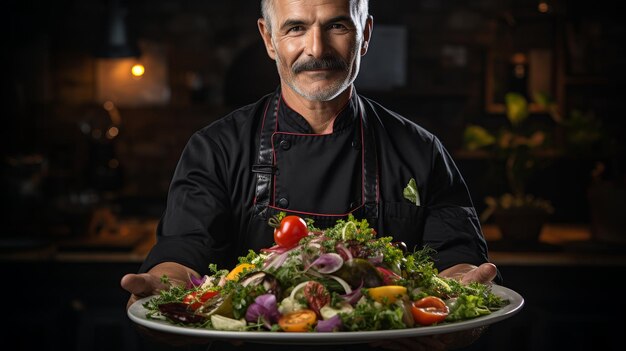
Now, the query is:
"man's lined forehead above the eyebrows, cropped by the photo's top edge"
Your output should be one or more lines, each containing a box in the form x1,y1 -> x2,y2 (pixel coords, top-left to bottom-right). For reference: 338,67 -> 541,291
274,0 -> 354,25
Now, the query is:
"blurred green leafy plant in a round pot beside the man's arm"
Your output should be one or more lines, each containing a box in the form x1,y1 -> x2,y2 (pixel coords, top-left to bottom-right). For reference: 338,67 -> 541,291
464,93 -> 554,242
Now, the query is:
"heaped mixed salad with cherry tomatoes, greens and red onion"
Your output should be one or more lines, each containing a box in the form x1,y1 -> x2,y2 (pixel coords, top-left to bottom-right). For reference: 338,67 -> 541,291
143,213 -> 509,332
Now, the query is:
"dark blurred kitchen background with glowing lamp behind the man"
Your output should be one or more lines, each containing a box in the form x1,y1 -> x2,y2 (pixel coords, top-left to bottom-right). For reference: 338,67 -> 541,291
0,0 -> 626,350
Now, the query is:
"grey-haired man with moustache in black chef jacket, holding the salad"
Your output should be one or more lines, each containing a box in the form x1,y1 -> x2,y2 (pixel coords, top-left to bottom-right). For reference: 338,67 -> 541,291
121,0 -> 496,348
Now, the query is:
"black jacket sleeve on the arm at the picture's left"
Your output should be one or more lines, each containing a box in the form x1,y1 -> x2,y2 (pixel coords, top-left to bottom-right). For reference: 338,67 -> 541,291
140,131 -> 232,274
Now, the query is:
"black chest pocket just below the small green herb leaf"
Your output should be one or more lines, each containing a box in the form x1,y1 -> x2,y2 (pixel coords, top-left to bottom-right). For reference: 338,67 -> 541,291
378,201 -> 426,251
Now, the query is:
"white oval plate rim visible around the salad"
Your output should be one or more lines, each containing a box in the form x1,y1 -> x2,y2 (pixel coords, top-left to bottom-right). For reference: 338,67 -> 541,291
128,284 -> 524,345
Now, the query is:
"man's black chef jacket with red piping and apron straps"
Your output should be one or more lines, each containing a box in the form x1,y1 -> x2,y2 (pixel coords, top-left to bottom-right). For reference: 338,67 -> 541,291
140,89 -> 487,274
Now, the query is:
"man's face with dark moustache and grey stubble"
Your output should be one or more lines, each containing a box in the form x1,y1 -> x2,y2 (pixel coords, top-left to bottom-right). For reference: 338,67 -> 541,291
259,0 -> 372,101
